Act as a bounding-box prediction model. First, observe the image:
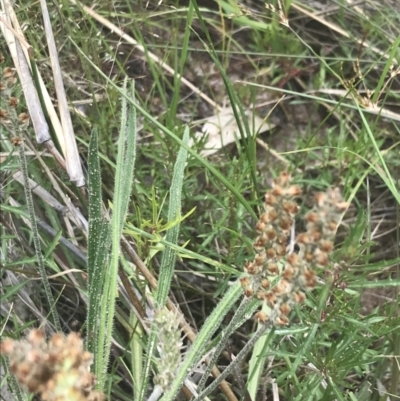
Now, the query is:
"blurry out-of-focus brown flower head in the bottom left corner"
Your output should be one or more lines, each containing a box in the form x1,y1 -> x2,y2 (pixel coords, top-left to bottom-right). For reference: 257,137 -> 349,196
1,330 -> 105,401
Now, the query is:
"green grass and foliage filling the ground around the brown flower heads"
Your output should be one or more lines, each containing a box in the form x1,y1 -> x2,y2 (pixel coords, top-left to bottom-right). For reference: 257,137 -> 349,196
0,0 -> 400,401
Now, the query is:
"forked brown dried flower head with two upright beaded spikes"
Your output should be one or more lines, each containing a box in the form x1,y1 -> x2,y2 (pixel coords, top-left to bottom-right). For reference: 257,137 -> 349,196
244,173 -> 349,326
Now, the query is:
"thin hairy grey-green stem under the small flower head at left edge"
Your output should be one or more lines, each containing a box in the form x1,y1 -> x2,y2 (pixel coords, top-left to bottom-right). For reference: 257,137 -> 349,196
18,141 -> 61,331
